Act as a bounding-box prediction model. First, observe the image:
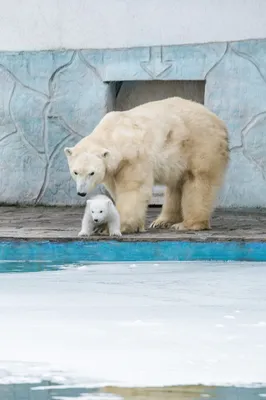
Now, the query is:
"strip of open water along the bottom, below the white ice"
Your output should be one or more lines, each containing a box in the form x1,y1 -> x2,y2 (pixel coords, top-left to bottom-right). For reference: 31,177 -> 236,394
0,382 -> 266,400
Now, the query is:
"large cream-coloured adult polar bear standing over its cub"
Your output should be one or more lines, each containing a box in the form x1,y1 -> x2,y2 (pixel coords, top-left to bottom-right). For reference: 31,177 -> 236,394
65,97 -> 229,233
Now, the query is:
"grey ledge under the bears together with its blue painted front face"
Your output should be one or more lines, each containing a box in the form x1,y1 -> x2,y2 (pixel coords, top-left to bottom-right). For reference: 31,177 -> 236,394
0,207 -> 266,266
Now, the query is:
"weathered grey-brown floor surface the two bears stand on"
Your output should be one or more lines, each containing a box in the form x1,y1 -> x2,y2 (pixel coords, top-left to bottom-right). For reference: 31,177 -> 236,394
0,206 -> 266,241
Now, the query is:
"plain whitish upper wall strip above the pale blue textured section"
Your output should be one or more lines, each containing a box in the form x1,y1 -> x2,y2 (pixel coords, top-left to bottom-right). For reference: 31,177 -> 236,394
0,0 -> 266,51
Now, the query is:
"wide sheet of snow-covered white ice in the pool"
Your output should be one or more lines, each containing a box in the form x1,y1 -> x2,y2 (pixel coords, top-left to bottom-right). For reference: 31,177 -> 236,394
0,262 -> 266,387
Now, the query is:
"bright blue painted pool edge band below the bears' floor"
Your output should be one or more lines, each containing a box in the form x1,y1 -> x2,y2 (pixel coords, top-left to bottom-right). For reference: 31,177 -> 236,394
0,240 -> 266,269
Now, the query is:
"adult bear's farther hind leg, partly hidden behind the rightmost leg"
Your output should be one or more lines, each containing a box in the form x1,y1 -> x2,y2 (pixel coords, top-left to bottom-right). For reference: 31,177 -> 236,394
150,186 -> 182,229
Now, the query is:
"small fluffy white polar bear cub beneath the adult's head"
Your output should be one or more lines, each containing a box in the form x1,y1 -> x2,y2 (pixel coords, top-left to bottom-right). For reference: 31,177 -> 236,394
79,195 -> 121,236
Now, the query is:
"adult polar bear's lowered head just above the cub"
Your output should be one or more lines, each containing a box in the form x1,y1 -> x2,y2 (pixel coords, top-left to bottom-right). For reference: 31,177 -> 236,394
64,147 -> 109,197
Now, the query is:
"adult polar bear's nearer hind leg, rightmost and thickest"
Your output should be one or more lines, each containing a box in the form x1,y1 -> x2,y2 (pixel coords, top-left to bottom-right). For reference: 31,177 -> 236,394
172,174 -> 219,231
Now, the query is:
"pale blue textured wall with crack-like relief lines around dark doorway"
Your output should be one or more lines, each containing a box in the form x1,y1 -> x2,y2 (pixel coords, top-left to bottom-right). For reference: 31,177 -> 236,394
0,40 -> 266,207
